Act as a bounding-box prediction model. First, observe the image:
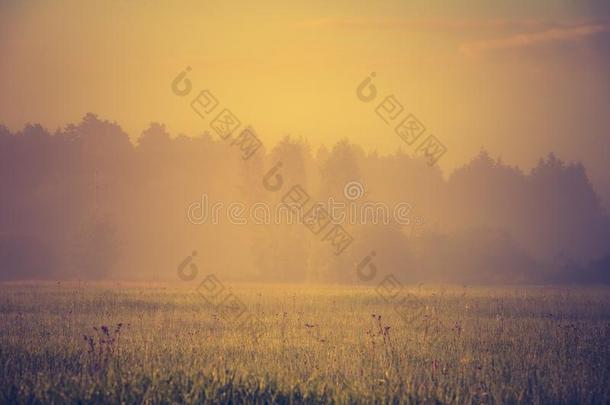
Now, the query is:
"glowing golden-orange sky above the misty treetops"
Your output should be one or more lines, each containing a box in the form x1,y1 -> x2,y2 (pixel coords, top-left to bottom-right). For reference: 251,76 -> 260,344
0,0 -> 610,205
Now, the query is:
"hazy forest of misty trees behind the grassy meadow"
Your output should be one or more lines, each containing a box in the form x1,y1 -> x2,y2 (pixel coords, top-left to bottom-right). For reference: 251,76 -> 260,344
0,113 -> 610,284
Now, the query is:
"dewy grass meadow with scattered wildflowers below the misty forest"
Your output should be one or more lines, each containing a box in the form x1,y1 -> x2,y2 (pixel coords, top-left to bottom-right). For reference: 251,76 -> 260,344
0,284 -> 610,403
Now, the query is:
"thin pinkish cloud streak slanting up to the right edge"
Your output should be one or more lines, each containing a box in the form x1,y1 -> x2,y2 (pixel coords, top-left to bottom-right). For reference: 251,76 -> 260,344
460,22 -> 610,55
